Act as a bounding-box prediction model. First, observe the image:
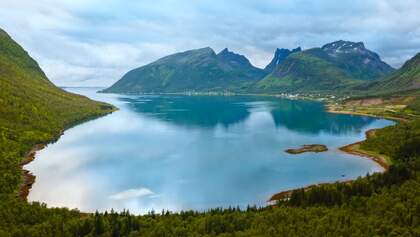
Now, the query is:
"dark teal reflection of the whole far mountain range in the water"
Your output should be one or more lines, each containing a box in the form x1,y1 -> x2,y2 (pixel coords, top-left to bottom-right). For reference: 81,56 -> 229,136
120,96 -> 374,134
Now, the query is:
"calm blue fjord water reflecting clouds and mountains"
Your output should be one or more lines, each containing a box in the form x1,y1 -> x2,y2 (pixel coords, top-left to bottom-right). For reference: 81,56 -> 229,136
25,88 -> 392,213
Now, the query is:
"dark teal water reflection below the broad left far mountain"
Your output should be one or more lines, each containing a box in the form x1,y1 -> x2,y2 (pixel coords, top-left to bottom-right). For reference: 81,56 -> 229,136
121,96 -> 250,127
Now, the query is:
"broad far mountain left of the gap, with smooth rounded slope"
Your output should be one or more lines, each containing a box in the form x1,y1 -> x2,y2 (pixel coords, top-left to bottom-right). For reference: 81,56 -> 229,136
103,47 -> 265,93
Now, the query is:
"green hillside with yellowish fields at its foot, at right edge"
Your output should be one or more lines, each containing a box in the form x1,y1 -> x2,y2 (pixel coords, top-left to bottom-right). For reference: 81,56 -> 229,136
329,53 -> 420,120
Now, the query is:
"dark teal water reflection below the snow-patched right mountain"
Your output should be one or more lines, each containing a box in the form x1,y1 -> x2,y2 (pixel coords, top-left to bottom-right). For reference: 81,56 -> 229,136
271,100 -> 375,134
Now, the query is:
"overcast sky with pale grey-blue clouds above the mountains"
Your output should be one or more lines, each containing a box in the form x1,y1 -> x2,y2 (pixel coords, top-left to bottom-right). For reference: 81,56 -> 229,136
0,0 -> 420,86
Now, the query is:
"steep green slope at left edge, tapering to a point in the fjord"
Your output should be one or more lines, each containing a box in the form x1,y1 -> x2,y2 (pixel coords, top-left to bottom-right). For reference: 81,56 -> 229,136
0,27 -> 114,198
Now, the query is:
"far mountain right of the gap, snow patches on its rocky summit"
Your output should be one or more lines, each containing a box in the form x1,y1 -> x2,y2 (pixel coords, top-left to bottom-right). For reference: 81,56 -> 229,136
253,40 -> 394,93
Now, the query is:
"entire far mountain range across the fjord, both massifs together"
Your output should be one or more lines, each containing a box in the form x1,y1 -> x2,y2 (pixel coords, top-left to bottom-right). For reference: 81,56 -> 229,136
103,40 -> 394,93
